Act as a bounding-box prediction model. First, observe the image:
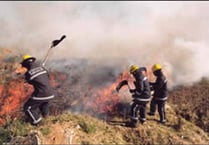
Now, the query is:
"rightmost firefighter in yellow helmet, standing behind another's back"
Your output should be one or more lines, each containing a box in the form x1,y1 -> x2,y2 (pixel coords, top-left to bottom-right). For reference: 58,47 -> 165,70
148,64 -> 168,123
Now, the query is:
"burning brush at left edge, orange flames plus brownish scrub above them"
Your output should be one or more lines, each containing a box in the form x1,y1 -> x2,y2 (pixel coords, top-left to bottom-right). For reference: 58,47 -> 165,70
0,59 -> 33,124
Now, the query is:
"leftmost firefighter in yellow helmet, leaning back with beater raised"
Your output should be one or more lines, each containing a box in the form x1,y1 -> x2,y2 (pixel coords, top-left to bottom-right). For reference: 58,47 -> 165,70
21,55 -> 54,125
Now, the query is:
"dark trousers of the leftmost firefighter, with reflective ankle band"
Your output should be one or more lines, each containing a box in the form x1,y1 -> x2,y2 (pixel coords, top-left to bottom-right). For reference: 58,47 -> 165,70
23,99 -> 48,125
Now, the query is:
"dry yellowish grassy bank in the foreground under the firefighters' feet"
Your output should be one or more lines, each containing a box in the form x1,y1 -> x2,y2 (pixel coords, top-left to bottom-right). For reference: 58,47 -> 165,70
0,104 -> 209,144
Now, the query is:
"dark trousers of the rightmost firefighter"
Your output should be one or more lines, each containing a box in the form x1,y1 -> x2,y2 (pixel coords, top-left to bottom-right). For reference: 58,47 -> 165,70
150,98 -> 166,122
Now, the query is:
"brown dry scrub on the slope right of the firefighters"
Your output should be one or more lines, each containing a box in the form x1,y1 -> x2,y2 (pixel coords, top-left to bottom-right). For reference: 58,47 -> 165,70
169,78 -> 209,133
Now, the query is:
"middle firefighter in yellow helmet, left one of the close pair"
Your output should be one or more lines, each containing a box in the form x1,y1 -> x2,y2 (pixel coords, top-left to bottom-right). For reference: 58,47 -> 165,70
127,65 -> 151,128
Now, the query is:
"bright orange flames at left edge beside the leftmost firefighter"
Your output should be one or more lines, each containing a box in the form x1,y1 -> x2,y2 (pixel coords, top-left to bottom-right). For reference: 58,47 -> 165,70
0,79 -> 33,124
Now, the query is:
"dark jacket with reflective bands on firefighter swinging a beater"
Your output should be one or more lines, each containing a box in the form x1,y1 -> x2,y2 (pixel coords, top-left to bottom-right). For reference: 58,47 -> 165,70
25,62 -> 54,101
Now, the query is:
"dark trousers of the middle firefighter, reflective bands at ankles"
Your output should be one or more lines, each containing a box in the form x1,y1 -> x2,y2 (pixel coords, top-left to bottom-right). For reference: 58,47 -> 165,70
130,101 -> 147,124
